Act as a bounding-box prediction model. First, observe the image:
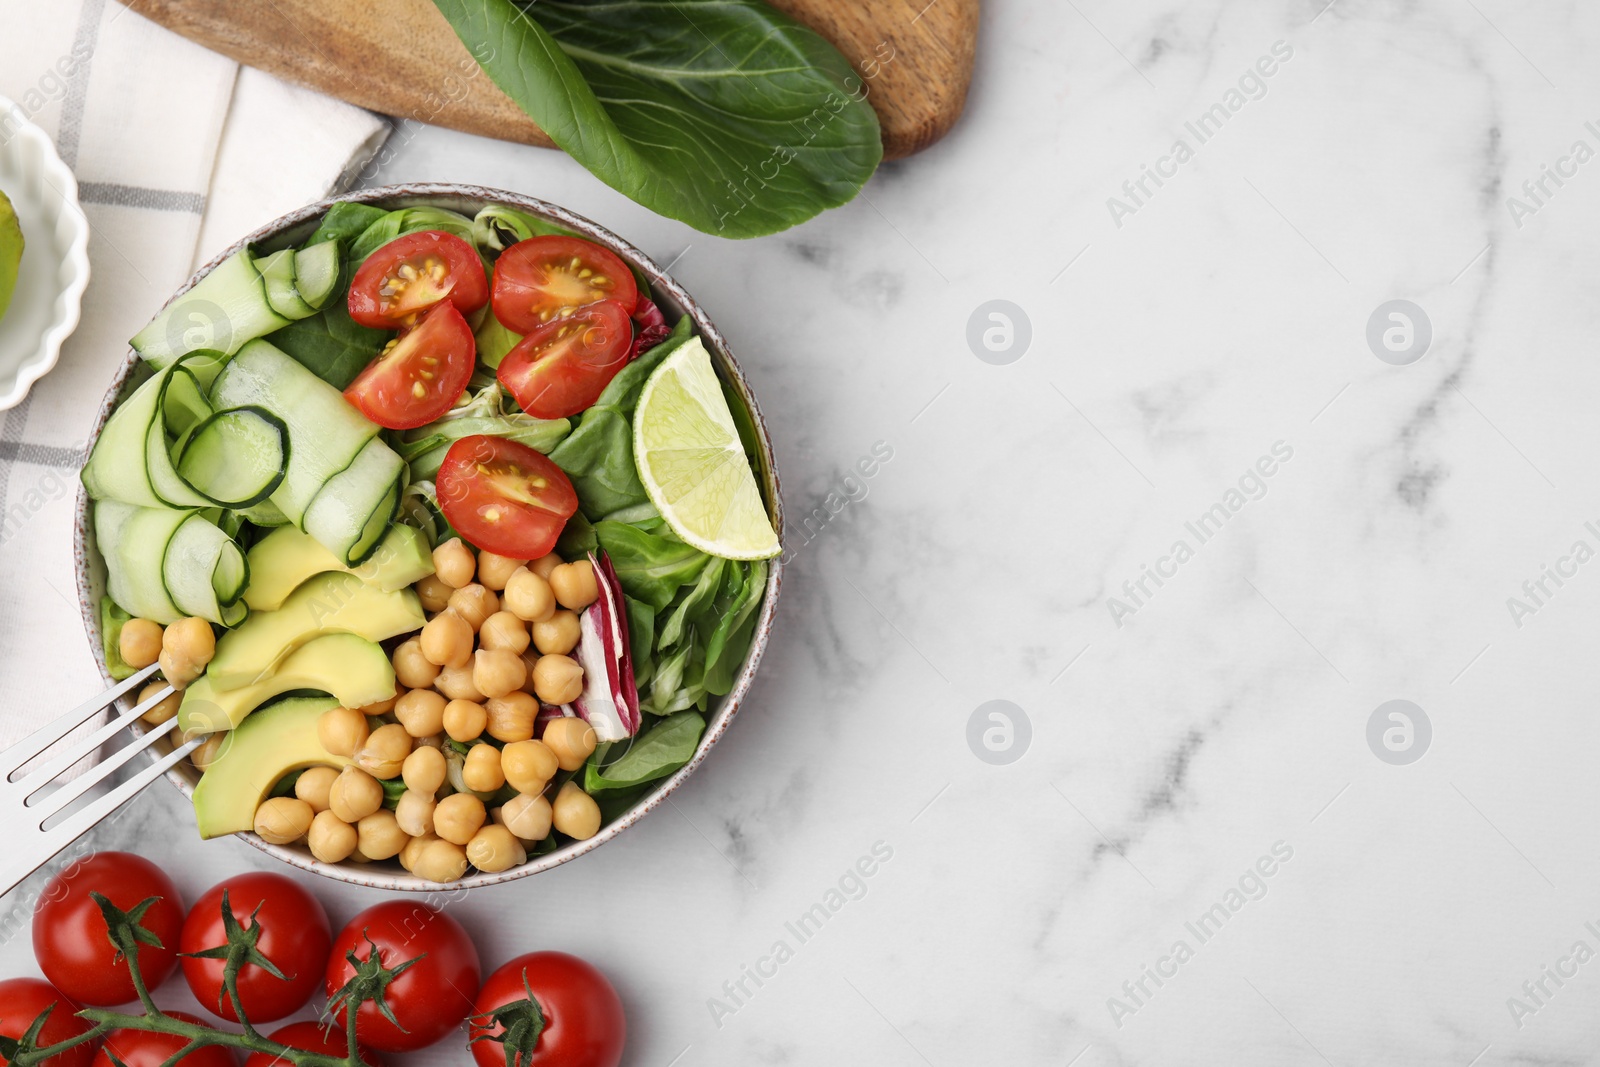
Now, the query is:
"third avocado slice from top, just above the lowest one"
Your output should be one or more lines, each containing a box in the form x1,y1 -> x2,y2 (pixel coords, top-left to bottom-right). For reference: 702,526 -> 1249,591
178,633 -> 395,734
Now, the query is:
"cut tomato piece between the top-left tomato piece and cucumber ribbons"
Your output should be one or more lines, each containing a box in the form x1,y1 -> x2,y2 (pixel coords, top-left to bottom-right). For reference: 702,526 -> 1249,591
344,304 -> 478,430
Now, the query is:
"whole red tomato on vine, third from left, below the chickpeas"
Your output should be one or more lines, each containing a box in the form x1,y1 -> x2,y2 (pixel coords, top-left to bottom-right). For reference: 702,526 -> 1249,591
326,901 -> 483,1053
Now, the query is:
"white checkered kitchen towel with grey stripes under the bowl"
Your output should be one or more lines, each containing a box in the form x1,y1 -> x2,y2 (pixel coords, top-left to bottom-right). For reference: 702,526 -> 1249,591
0,0 -> 389,747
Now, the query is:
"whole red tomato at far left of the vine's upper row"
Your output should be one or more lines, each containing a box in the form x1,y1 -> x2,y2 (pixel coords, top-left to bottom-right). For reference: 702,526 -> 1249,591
34,853 -> 184,1008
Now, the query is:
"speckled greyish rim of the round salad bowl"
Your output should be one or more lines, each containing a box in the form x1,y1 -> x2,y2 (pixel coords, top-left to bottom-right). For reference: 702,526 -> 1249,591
74,182 -> 784,893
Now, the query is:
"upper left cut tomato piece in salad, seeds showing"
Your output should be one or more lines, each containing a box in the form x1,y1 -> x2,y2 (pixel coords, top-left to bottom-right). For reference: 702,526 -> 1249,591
349,230 -> 490,330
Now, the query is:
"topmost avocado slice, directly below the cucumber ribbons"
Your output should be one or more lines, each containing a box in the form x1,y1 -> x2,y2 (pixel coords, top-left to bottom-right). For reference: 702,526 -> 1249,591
245,525 -> 434,611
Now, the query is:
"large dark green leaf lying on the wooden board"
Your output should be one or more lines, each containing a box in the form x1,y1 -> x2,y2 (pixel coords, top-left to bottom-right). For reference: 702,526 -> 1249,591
434,0 -> 883,237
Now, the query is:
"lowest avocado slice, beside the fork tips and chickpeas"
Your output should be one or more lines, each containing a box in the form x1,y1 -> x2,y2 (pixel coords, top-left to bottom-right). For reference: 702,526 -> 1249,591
195,696 -> 350,838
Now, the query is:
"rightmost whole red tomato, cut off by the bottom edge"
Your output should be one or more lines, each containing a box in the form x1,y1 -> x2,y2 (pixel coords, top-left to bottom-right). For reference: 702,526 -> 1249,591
472,952 -> 627,1067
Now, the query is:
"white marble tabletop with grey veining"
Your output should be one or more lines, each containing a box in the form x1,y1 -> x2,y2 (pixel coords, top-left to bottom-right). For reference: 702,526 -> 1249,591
9,0 -> 1600,1067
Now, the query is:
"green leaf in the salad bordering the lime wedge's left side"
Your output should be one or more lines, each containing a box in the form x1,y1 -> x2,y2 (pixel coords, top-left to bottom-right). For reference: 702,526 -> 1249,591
550,315 -> 693,518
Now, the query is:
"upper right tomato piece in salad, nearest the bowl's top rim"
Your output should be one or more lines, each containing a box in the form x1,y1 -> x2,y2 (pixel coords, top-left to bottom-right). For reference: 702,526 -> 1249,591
494,237 -> 638,333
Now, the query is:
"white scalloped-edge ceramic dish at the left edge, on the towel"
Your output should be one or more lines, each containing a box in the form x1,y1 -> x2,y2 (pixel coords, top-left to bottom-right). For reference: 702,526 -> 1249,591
0,96 -> 90,411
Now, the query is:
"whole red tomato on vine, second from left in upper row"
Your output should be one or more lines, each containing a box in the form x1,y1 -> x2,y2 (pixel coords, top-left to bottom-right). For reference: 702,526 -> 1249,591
179,872 -> 333,1024
